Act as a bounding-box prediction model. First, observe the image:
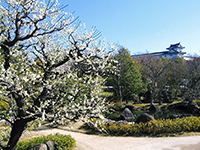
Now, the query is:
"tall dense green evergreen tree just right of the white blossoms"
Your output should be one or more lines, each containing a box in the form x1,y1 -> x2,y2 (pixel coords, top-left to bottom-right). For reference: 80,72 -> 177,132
107,47 -> 144,102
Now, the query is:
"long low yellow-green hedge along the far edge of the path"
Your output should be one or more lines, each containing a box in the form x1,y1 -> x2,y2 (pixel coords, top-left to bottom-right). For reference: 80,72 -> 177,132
101,117 -> 200,136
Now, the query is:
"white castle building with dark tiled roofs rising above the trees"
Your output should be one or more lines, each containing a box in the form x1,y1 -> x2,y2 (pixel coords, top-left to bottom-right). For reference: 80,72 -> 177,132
132,42 -> 186,59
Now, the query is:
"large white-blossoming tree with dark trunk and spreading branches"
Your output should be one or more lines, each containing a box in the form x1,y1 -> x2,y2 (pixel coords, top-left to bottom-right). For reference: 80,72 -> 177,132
0,0 -> 115,150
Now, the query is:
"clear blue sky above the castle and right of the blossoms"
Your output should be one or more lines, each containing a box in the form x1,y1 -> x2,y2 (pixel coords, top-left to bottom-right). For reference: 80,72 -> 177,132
60,0 -> 200,55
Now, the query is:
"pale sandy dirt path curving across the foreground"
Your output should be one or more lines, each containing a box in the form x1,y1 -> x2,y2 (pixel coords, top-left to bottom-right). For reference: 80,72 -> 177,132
22,129 -> 200,150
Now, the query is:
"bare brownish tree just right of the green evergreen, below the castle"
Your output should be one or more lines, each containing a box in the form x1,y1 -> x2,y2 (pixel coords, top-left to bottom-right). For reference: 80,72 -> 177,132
140,56 -> 172,104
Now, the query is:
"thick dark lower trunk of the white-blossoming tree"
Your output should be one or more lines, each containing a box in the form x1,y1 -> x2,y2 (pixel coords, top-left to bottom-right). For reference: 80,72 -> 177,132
4,119 -> 27,150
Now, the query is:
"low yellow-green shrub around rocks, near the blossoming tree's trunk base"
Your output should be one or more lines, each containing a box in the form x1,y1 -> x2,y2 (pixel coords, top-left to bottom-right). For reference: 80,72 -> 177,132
17,133 -> 76,150
